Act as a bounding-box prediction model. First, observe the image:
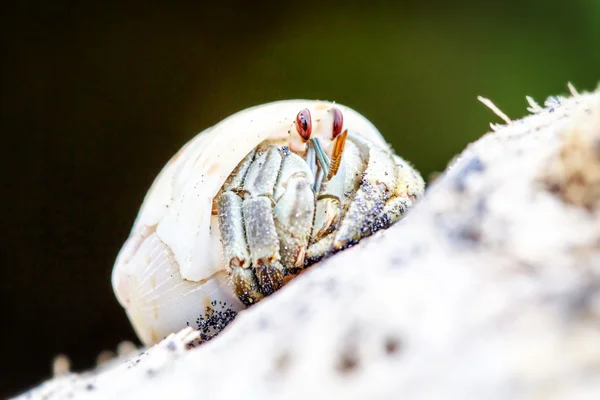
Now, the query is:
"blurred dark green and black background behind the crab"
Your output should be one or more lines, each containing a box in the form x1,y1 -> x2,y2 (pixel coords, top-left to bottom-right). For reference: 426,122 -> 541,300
0,0 -> 600,397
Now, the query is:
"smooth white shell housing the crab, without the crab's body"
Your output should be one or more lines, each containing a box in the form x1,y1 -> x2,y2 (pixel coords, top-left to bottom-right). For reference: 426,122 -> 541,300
112,100 -> 388,345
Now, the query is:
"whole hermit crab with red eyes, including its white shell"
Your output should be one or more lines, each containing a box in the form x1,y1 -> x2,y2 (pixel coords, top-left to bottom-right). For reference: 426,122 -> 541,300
112,100 -> 424,345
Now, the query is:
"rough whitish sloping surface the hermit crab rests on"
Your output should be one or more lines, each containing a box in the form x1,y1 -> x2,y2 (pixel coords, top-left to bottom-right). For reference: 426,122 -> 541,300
15,88 -> 600,399
